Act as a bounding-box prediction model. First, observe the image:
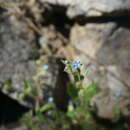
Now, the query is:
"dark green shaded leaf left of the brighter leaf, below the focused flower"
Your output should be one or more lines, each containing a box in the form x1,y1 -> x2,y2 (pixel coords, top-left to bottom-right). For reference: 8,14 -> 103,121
67,83 -> 79,98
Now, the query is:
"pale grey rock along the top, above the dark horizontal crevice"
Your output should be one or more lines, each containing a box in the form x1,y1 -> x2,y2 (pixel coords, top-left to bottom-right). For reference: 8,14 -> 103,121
41,0 -> 130,18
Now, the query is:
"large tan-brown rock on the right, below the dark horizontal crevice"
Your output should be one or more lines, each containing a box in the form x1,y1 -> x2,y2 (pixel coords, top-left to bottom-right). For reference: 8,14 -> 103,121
70,21 -> 130,119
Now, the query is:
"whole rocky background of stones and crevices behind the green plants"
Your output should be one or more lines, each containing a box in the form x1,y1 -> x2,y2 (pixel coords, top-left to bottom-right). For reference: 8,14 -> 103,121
0,0 -> 130,130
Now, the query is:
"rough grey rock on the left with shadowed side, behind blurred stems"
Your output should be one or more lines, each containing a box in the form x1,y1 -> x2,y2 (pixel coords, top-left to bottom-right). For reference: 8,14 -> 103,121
0,16 -> 69,109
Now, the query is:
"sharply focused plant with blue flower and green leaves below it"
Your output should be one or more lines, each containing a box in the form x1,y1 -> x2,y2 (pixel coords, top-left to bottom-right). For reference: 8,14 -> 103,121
63,60 -> 100,130
